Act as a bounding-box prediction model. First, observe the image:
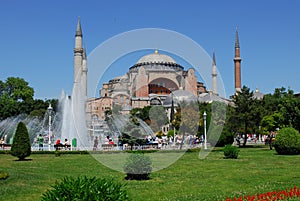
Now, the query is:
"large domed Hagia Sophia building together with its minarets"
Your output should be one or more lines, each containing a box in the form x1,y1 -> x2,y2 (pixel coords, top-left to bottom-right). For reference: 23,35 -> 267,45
70,19 -> 259,132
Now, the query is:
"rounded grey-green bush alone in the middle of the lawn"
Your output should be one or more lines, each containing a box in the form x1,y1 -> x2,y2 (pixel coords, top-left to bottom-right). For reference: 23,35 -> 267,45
124,153 -> 152,180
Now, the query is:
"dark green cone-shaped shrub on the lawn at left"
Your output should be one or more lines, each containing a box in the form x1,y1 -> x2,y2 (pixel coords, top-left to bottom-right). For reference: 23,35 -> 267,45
11,122 -> 31,160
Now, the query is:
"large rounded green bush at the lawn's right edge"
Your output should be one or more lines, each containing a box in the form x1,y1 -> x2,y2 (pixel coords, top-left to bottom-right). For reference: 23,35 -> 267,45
273,128 -> 300,155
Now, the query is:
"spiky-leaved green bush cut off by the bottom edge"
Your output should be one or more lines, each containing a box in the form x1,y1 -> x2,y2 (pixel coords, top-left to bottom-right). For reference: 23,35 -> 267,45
41,176 -> 129,201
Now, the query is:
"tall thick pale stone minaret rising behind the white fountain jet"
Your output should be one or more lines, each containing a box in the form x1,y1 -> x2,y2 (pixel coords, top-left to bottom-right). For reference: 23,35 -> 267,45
74,17 -> 83,84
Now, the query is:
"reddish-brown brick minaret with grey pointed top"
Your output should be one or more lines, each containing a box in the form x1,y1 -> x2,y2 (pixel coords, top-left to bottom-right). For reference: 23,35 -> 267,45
233,28 -> 242,92
